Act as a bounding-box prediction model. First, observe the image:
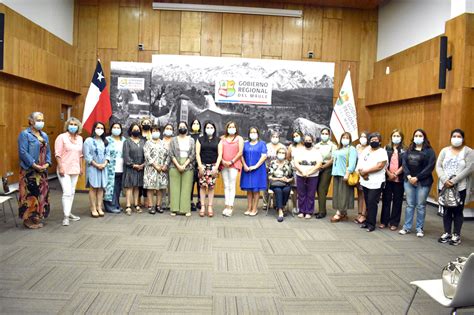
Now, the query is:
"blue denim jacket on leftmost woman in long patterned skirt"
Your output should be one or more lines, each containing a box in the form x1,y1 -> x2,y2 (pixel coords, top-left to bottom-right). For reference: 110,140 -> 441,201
18,127 -> 51,170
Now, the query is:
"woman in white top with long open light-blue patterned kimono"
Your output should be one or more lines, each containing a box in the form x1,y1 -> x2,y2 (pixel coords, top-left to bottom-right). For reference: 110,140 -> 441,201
104,123 -> 125,213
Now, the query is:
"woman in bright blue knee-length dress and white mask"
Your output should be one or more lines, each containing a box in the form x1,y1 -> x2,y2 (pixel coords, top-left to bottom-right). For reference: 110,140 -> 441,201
240,127 -> 267,216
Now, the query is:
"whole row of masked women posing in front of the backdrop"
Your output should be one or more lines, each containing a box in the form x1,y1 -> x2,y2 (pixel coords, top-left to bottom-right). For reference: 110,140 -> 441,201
18,112 -> 473,245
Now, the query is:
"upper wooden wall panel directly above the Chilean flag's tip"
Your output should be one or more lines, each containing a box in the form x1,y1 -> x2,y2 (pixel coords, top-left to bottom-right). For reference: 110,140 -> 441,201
97,0 -> 119,48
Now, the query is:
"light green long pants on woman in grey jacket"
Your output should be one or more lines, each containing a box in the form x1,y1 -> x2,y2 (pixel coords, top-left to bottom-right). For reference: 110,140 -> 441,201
169,161 -> 194,214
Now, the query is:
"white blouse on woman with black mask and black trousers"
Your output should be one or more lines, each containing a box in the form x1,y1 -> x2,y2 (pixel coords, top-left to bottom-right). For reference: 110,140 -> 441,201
356,147 -> 388,189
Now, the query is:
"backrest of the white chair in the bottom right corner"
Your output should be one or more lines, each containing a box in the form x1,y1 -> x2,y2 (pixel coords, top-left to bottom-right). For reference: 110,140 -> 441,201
450,253 -> 474,307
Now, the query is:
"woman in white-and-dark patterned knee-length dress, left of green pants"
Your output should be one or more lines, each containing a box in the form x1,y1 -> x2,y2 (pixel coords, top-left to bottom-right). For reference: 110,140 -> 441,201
143,125 -> 170,214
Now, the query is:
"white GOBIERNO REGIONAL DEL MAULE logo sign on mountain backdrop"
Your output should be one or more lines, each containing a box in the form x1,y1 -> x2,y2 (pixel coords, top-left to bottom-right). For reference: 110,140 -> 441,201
214,78 -> 272,105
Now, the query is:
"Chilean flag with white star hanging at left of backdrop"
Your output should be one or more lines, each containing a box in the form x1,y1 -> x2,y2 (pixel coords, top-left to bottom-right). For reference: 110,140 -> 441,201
82,60 -> 112,134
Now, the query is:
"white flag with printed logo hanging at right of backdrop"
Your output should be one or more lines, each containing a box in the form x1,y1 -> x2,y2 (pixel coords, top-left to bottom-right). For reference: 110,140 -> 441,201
329,70 -> 359,142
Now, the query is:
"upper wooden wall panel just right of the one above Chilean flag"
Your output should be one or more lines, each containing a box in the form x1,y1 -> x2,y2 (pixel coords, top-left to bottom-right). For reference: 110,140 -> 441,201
117,7 -> 140,61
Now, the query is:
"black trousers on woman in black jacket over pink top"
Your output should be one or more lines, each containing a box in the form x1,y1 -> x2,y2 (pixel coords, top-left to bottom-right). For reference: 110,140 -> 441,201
380,181 -> 405,226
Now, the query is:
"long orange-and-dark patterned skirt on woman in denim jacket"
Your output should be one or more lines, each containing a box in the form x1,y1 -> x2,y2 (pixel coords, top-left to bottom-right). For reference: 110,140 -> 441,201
18,168 -> 49,220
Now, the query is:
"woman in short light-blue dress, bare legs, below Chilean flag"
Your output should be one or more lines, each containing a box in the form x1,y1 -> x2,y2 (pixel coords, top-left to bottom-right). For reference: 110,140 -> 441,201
84,121 -> 110,218
